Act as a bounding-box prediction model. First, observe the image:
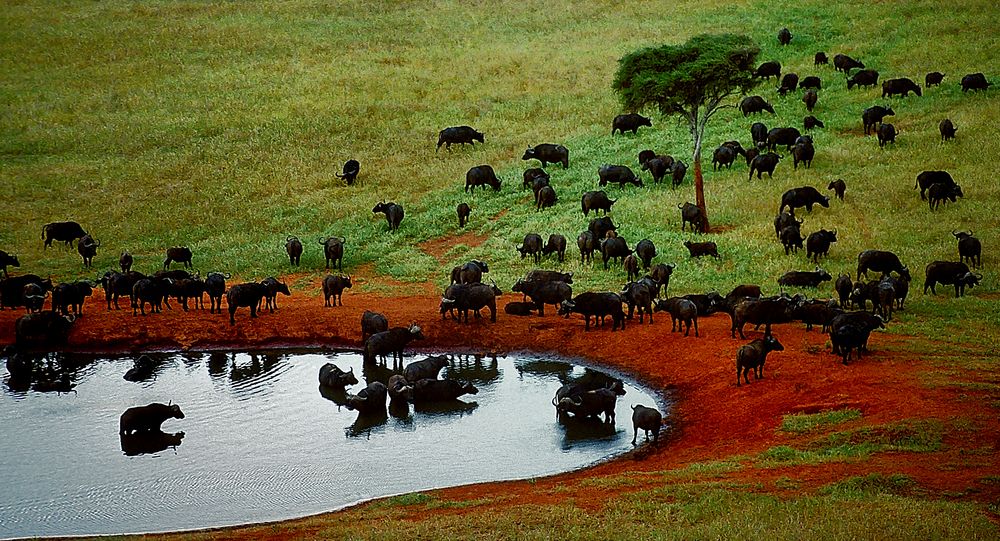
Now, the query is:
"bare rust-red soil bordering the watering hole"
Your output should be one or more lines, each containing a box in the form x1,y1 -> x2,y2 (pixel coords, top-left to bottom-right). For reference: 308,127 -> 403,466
0,279 -> 1000,537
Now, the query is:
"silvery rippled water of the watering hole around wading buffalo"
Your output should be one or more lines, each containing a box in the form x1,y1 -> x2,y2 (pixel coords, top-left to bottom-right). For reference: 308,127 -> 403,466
0,351 -> 662,538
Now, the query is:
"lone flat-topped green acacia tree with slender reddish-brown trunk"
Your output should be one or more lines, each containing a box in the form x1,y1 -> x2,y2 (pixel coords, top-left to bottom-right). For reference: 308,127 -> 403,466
611,34 -> 760,232
